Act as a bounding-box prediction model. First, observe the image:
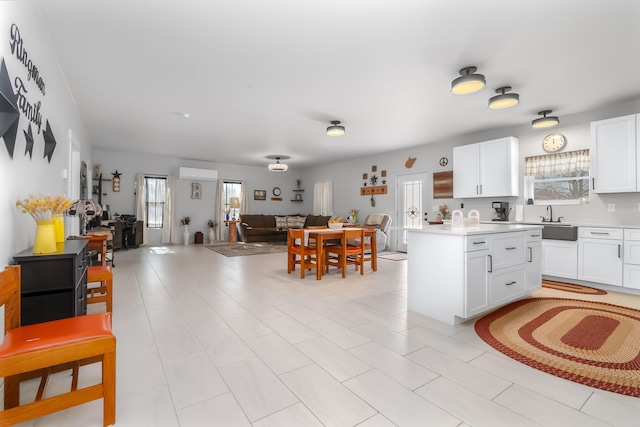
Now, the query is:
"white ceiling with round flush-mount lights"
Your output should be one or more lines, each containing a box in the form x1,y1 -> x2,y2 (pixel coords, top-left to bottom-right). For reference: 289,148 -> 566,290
36,0 -> 640,169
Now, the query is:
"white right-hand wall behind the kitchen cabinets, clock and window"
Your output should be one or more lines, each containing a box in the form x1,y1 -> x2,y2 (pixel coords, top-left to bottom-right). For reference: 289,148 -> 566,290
304,99 -> 640,248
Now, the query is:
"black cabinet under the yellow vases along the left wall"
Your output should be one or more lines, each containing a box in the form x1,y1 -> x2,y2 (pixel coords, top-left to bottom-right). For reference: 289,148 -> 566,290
14,240 -> 88,326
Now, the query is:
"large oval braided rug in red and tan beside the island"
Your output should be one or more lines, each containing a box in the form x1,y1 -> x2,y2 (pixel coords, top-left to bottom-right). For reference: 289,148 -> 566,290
475,298 -> 640,397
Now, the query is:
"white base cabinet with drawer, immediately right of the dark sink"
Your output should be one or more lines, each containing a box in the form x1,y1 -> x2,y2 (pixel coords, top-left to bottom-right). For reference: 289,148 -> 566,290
578,227 -> 624,286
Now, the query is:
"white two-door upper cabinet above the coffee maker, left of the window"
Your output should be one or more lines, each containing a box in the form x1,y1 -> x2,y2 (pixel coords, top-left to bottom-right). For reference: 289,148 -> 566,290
453,136 -> 518,198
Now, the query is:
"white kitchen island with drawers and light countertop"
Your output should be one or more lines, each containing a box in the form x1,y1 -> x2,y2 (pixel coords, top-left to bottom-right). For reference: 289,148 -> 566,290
406,224 -> 542,324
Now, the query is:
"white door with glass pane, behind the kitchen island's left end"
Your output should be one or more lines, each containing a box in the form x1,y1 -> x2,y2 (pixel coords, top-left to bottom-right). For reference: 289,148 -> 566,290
396,172 -> 433,252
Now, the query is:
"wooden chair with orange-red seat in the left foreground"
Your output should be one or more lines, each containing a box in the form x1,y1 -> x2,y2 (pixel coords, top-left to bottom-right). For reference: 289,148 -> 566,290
0,265 -> 116,427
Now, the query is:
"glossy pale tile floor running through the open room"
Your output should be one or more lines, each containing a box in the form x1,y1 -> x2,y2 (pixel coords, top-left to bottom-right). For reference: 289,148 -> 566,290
7,245 -> 640,427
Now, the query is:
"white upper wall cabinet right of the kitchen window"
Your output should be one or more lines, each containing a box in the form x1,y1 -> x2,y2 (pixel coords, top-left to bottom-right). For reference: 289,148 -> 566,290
591,114 -> 640,193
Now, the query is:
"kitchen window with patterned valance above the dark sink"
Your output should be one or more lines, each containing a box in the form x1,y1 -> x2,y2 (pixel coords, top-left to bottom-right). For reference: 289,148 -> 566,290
525,150 -> 590,204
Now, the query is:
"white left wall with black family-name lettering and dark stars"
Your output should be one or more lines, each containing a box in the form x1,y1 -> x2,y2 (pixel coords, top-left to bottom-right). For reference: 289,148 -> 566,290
0,0 -> 92,268
